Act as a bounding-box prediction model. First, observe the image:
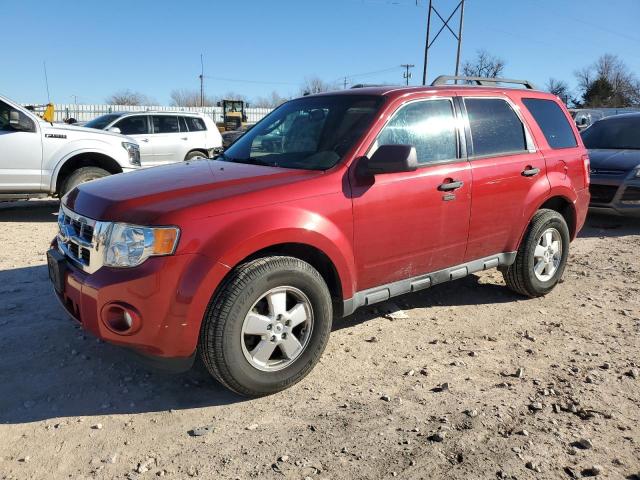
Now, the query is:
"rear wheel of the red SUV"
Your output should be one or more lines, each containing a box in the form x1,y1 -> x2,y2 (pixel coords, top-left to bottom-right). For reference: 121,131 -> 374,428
502,209 -> 570,297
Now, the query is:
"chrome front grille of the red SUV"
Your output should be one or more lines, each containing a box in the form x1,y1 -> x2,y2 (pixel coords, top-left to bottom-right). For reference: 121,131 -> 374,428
56,205 -> 108,273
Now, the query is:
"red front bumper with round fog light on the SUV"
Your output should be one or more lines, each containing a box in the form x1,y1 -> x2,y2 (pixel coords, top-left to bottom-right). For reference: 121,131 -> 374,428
52,242 -> 228,371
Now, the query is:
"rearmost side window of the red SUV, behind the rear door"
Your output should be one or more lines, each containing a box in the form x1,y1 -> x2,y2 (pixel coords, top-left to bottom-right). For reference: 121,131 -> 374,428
522,98 -> 578,148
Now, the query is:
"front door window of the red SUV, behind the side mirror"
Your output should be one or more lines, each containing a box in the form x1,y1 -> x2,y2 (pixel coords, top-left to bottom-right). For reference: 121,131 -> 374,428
370,99 -> 458,164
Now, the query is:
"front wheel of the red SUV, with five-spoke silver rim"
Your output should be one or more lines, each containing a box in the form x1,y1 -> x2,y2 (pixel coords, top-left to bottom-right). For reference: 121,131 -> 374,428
198,256 -> 333,396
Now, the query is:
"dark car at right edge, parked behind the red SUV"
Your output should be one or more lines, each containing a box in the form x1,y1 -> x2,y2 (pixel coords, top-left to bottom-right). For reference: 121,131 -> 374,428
582,113 -> 640,216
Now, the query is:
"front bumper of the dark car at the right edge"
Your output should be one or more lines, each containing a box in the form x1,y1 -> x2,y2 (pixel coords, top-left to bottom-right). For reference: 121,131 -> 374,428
589,175 -> 640,216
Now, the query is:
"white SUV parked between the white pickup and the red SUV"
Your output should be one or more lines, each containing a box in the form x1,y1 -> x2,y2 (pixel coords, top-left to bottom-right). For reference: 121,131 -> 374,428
85,112 -> 222,167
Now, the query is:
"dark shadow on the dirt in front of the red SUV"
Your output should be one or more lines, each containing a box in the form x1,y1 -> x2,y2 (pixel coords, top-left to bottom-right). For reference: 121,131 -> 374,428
0,266 -> 243,424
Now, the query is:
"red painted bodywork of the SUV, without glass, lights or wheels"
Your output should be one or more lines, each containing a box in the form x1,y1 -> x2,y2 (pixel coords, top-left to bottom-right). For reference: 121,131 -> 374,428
53,86 -> 589,357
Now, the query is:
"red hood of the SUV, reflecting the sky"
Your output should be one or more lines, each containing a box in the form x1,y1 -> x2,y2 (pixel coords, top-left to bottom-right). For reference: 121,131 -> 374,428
63,160 -> 323,225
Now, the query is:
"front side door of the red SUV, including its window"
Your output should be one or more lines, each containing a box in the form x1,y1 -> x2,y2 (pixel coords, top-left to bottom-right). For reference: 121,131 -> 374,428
351,98 -> 471,290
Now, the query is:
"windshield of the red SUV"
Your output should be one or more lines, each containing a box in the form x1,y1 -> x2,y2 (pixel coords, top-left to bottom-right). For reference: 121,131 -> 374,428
222,95 -> 383,170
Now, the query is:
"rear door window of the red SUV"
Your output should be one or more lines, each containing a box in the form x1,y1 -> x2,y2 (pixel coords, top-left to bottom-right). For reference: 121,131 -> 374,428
464,98 -> 527,157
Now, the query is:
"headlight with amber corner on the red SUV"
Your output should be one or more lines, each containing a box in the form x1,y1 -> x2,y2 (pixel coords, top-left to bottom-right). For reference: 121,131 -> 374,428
104,223 -> 180,267
